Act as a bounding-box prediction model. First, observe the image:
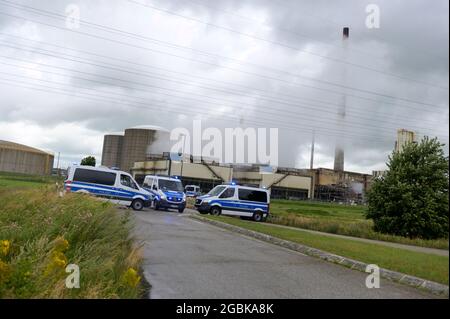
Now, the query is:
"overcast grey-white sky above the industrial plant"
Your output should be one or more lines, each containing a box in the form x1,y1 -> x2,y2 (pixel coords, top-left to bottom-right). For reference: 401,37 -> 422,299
0,0 -> 449,173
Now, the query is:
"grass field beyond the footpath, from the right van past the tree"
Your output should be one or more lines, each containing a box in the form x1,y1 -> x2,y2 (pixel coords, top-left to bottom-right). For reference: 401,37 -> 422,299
268,200 -> 449,249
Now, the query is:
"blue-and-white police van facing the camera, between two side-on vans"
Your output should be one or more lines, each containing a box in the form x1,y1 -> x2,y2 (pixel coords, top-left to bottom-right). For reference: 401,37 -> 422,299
142,175 -> 186,213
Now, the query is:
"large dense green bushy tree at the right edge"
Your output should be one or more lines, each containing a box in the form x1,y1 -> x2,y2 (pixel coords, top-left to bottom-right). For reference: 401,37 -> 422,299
366,137 -> 449,239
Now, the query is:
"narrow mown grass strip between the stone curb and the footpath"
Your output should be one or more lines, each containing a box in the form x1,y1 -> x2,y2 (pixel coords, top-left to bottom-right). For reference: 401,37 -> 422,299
204,215 -> 449,285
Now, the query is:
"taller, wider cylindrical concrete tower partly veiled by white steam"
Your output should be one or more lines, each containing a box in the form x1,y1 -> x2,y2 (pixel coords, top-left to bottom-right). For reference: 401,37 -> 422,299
120,126 -> 168,172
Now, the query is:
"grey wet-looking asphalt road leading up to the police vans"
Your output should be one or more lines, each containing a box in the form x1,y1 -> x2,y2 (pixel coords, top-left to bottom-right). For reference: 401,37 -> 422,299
133,210 -> 433,299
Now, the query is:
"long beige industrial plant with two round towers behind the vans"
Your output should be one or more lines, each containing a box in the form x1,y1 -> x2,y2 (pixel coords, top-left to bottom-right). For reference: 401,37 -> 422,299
101,126 -> 371,202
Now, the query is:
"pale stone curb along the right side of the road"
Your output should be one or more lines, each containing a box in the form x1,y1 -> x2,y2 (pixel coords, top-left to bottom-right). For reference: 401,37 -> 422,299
190,215 -> 449,298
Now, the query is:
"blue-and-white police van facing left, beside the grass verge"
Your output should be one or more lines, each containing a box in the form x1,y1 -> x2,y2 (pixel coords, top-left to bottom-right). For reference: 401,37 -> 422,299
195,184 -> 270,222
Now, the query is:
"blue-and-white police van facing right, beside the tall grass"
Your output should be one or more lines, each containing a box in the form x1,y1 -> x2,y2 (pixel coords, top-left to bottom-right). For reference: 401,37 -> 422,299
64,165 -> 152,210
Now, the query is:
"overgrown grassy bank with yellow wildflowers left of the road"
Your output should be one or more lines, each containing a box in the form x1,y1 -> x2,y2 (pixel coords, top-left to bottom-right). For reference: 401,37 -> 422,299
0,174 -> 144,298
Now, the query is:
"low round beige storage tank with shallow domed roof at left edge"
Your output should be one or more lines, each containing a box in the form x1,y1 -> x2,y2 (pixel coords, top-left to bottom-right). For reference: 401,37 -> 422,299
0,140 -> 54,175
